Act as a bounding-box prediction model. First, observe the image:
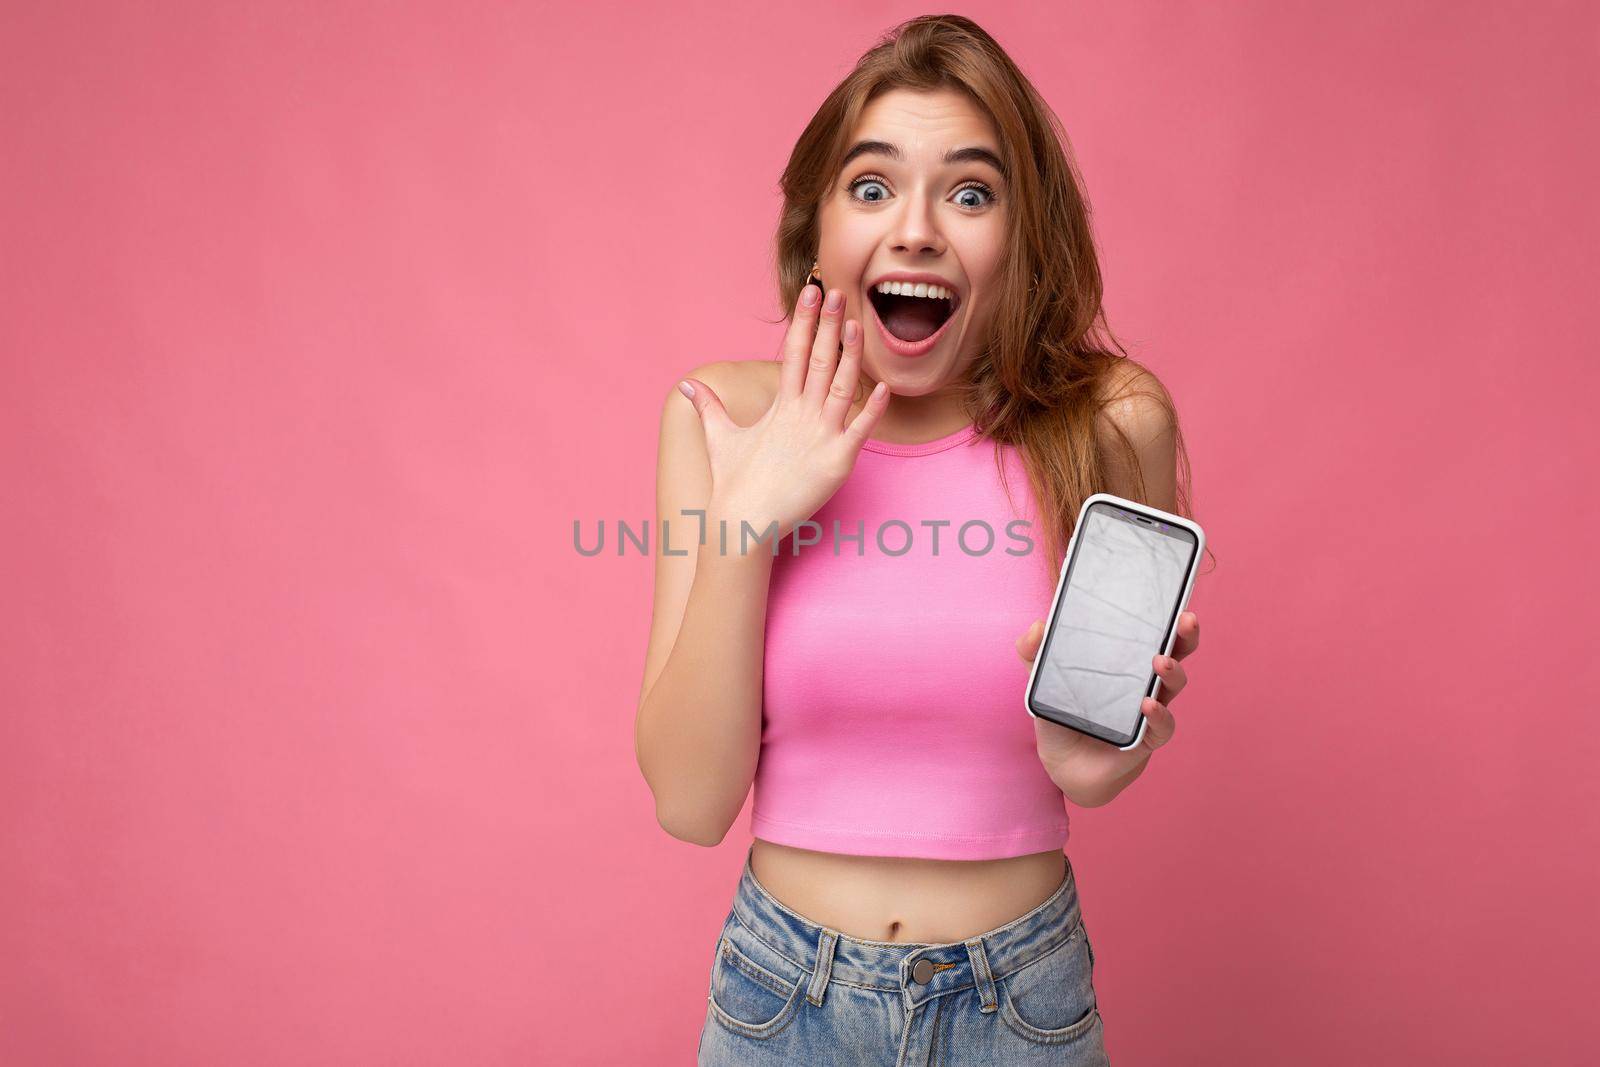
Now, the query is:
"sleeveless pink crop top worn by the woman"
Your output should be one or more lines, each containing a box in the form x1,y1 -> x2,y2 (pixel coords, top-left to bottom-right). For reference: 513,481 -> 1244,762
752,426 -> 1067,859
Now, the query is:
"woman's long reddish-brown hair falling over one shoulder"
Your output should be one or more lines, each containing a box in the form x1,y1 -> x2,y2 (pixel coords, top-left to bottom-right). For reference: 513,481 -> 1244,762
776,14 -> 1190,585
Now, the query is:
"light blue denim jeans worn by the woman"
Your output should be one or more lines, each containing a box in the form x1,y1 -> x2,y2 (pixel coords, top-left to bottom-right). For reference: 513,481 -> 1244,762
699,853 -> 1109,1067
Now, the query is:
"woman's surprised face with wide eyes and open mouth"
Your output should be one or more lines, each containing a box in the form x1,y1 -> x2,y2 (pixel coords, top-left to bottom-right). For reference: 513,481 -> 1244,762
818,90 -> 1010,397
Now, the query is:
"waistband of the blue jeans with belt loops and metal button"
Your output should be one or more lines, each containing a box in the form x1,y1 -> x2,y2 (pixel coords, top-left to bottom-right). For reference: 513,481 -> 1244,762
733,845 -> 1082,1013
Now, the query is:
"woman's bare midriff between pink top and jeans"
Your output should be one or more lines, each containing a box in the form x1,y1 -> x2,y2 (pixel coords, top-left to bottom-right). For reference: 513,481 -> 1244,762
750,838 -> 1066,944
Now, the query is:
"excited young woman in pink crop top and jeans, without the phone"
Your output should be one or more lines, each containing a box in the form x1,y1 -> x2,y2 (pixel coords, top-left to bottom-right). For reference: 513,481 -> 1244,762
635,16 -> 1198,1064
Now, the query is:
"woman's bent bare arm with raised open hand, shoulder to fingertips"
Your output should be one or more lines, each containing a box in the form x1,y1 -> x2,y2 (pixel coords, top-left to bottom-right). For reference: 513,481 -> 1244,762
634,286 -> 890,845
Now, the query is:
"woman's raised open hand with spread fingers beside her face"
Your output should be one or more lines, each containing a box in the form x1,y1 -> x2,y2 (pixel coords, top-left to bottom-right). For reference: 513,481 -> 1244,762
678,285 -> 890,544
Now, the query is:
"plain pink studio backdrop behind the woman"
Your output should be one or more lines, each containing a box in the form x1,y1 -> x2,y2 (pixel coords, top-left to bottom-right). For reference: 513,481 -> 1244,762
0,2 -> 1600,1067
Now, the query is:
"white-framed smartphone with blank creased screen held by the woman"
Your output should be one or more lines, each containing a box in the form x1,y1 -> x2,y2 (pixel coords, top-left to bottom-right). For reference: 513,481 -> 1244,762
1026,493 -> 1205,750
